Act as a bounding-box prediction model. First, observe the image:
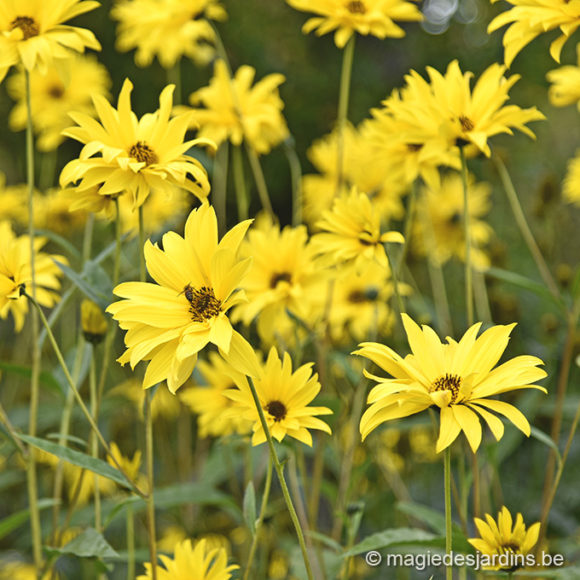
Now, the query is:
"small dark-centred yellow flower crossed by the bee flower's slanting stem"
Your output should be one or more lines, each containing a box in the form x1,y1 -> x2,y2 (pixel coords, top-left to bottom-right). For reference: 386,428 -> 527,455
225,347 -> 332,446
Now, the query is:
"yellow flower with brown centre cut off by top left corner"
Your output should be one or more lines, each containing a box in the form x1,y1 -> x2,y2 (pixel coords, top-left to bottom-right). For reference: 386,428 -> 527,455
0,0 -> 101,82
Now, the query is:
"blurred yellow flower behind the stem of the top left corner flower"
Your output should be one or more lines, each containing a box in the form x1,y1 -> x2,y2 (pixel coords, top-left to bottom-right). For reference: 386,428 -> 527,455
8,55 -> 111,151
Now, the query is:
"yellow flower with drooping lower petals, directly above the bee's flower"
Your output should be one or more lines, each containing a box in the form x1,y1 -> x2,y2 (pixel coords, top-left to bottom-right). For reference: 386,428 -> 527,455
60,80 -> 213,206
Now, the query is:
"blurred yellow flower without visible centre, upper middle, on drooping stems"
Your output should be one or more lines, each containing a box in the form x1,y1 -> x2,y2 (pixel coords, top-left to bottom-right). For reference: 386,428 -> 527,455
189,59 -> 288,154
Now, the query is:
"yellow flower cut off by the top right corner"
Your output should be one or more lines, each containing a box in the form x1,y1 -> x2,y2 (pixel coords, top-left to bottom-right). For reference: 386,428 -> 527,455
487,0 -> 580,66
